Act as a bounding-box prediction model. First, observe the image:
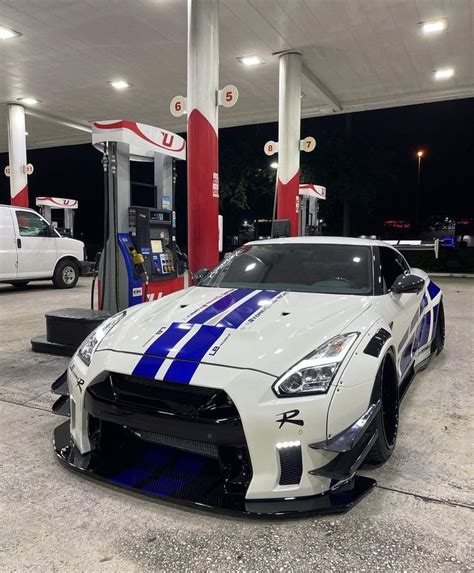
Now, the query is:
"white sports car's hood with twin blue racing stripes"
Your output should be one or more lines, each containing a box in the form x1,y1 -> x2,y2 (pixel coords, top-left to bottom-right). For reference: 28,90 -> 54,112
100,287 -> 371,376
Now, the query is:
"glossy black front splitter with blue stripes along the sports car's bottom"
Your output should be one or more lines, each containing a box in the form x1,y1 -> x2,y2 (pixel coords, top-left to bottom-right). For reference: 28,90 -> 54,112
53,420 -> 376,518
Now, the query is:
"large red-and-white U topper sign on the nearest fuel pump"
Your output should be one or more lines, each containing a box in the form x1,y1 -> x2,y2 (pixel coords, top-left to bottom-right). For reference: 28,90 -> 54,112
92,119 -> 186,161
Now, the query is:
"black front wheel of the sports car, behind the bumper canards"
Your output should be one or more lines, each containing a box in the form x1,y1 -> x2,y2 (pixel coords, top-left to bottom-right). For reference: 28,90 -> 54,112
366,354 -> 399,464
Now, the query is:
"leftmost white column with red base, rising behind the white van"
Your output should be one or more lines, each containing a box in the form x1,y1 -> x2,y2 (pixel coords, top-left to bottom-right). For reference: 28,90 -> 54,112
8,103 -> 28,207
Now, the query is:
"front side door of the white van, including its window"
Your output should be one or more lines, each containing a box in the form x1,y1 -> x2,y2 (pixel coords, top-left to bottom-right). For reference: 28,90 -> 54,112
15,209 -> 57,279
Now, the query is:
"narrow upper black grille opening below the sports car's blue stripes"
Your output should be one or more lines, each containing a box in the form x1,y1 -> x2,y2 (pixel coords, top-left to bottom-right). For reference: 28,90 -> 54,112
108,372 -> 239,420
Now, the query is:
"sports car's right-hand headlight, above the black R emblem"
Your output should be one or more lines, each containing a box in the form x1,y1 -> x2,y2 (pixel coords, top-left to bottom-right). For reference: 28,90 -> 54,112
273,332 -> 359,398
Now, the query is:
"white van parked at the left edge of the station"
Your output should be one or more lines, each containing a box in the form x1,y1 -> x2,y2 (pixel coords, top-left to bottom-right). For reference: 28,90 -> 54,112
0,205 -> 86,288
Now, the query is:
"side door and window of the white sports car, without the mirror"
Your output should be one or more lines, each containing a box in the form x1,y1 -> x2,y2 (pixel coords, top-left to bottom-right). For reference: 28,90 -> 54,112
379,247 -> 424,378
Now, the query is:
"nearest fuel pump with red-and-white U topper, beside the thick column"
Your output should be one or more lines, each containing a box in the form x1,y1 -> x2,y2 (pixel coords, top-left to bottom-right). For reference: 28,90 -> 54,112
92,120 -> 187,312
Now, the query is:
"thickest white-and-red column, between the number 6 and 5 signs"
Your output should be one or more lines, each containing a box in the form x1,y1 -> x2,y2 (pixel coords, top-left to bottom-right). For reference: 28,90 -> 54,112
187,0 -> 219,272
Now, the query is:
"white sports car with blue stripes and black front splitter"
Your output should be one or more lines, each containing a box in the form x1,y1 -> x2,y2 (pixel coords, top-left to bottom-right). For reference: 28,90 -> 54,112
53,237 -> 444,515
